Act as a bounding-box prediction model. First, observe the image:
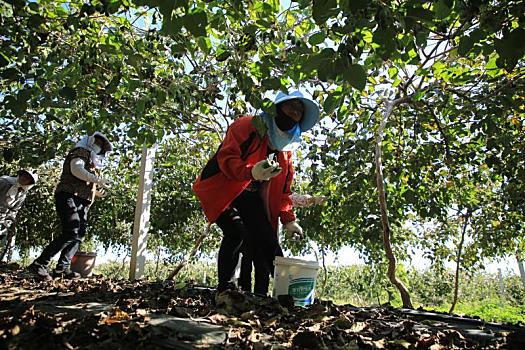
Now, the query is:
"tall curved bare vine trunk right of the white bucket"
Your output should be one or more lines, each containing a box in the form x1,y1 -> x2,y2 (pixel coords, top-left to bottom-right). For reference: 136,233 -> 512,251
375,97 -> 413,309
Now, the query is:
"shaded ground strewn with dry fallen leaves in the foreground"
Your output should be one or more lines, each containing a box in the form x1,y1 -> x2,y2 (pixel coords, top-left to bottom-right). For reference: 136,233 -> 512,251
0,264 -> 525,350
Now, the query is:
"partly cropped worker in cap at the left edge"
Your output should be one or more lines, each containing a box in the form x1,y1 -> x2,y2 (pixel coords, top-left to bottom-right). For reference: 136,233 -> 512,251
0,169 -> 38,256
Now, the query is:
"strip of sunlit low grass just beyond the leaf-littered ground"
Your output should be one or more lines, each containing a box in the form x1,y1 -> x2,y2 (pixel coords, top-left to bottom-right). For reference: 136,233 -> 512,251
91,260 -> 525,324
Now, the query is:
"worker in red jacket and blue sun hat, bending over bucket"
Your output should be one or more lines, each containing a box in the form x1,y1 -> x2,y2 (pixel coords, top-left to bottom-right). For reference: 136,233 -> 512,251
193,91 -> 319,295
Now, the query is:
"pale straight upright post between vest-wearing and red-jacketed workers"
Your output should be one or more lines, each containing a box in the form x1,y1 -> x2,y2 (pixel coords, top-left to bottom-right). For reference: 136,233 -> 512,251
129,144 -> 157,280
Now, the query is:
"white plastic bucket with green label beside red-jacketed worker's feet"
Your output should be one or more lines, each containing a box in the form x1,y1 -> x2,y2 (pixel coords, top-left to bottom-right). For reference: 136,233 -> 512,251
272,256 -> 319,306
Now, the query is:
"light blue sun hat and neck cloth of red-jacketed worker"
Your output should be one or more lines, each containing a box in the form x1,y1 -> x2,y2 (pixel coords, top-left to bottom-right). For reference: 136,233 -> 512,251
261,91 -> 319,151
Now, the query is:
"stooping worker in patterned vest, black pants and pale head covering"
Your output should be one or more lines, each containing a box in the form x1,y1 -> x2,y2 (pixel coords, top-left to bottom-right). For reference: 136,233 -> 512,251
28,132 -> 113,280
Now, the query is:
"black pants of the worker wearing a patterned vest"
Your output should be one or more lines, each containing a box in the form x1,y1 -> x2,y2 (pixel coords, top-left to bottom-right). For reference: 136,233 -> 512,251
35,192 -> 90,270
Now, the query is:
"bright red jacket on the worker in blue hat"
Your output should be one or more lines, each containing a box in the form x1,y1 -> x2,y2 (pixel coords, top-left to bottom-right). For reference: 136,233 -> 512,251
192,116 -> 295,233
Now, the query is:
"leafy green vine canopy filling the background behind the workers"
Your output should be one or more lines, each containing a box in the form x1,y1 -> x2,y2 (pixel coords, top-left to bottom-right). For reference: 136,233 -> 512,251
0,0 -> 525,312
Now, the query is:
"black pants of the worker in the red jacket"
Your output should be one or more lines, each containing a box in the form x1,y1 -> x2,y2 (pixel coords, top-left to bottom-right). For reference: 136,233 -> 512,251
217,191 -> 282,294
